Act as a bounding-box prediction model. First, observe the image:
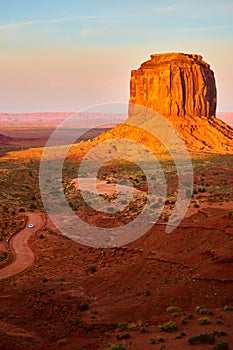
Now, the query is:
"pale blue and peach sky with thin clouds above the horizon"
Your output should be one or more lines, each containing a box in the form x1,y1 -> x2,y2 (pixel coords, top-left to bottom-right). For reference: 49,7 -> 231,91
0,0 -> 233,113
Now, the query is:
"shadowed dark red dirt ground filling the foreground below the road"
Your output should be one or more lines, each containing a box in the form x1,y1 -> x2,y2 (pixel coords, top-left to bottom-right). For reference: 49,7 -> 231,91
0,202 -> 233,350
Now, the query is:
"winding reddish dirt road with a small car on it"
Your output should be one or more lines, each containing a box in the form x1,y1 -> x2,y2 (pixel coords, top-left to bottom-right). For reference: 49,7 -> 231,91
0,213 -> 44,280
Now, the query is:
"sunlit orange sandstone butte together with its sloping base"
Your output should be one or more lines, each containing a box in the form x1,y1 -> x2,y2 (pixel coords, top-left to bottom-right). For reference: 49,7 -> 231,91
0,53 -> 233,163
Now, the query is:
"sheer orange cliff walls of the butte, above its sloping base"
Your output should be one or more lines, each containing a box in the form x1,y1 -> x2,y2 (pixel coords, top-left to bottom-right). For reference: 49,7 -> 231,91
130,53 -> 216,118
